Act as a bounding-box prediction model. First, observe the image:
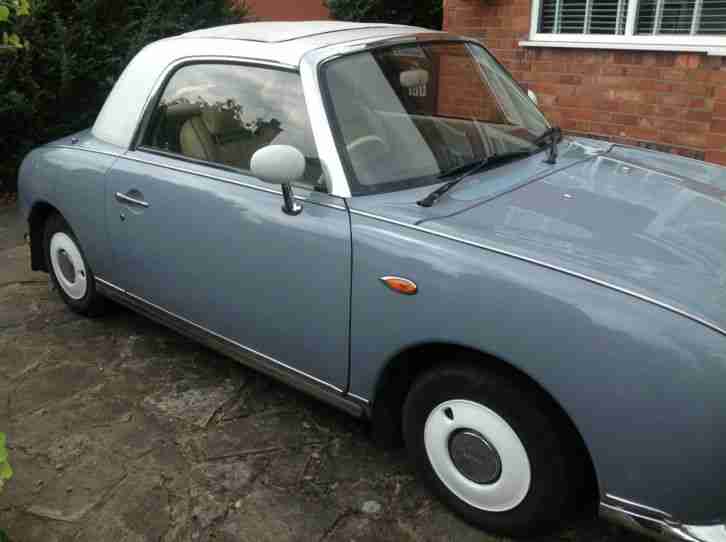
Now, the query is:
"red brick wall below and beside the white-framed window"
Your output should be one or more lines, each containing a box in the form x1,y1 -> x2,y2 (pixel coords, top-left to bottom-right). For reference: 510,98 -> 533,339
444,0 -> 726,164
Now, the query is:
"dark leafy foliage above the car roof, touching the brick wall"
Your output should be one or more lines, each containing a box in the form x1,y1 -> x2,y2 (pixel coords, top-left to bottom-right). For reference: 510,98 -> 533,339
325,0 -> 443,28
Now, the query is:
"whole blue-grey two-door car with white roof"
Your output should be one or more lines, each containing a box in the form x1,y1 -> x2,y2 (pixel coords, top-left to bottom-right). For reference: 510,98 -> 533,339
19,22 -> 726,542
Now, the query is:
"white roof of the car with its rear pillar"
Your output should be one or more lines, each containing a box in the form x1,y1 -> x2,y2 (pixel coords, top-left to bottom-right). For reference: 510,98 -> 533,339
93,21 -> 433,148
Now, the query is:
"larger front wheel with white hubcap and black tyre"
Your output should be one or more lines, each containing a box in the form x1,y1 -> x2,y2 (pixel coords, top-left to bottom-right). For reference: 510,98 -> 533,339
403,363 -> 584,537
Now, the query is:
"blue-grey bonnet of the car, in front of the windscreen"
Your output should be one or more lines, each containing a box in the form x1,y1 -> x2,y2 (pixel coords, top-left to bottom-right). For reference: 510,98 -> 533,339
423,141 -> 726,336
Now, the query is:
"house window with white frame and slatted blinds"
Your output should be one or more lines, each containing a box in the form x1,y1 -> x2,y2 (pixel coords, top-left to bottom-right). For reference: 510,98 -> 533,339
521,0 -> 726,55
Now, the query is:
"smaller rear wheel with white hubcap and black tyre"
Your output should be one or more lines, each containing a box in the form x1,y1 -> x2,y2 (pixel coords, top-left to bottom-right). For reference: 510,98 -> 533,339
43,213 -> 106,316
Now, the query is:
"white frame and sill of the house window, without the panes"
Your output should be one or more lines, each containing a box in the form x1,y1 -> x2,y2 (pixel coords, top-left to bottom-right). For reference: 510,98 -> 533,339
519,0 -> 726,56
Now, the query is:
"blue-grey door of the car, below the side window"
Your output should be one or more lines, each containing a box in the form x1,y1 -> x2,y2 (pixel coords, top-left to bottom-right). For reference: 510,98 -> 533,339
102,151 -> 351,391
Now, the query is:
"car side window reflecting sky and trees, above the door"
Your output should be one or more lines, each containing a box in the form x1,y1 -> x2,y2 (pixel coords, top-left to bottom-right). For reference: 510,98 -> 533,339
141,64 -> 324,189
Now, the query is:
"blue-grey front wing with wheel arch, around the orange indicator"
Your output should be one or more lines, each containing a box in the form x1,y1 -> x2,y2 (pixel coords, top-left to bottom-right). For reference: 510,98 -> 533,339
351,210 -> 726,522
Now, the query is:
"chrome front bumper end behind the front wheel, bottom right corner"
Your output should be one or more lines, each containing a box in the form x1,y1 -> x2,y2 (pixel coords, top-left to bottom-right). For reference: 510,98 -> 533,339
600,495 -> 726,542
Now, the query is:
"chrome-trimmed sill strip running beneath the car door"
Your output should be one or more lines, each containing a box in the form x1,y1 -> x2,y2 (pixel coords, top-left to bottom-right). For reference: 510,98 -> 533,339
94,277 -> 368,417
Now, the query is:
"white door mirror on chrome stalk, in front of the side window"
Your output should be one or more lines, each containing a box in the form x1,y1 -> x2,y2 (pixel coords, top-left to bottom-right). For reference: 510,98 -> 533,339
250,149 -> 305,219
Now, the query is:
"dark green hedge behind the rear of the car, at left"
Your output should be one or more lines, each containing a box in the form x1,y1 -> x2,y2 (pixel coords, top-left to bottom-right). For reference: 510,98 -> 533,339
0,0 -> 243,192
